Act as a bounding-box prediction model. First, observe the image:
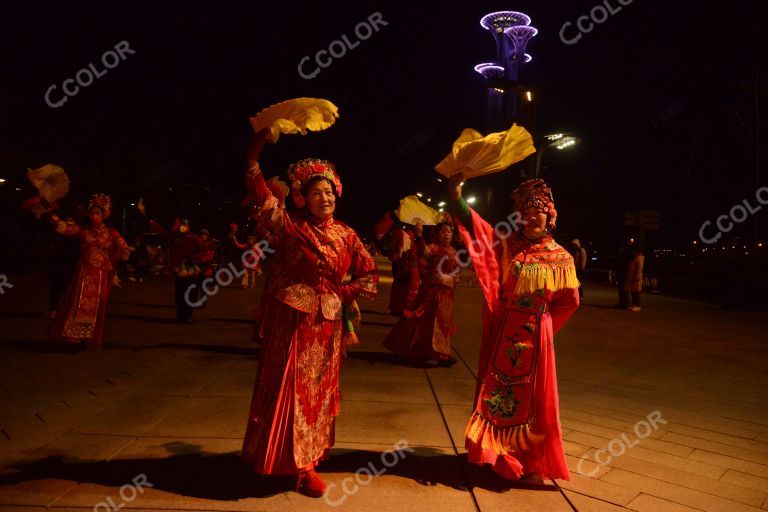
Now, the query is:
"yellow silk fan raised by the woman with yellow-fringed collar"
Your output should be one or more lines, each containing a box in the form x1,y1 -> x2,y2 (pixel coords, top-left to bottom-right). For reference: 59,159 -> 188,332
435,124 -> 536,178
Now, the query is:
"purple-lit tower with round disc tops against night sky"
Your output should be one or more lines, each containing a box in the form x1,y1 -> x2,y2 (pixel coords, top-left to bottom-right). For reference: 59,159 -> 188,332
475,11 -> 538,130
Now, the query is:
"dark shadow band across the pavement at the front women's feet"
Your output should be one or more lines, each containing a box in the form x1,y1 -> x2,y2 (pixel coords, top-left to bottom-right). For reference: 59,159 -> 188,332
0,441 -> 557,501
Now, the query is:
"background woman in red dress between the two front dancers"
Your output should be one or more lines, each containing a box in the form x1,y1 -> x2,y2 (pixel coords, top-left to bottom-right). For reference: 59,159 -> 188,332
384,223 -> 459,365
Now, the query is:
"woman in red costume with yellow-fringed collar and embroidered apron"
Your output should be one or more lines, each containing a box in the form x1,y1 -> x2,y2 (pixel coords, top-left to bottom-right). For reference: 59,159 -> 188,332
448,173 -> 579,480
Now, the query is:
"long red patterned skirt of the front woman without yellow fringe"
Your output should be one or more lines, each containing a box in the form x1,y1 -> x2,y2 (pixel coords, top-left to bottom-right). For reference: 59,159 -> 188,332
242,297 -> 341,475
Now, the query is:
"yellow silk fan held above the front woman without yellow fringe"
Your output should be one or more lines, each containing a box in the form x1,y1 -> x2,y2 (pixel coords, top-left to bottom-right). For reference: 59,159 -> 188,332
251,98 -> 339,142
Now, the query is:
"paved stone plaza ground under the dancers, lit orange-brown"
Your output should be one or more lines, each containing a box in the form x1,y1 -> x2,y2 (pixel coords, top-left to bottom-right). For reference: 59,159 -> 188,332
0,262 -> 768,512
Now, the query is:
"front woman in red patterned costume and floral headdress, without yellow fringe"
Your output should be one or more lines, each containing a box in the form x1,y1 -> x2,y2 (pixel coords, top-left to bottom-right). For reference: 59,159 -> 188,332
242,132 -> 378,497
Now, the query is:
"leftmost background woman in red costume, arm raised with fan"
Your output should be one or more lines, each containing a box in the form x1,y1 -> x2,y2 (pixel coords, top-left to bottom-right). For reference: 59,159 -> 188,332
48,194 -> 130,348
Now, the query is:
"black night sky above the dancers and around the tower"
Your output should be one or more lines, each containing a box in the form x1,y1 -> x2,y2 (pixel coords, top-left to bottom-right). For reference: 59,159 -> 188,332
0,0 -> 768,255
